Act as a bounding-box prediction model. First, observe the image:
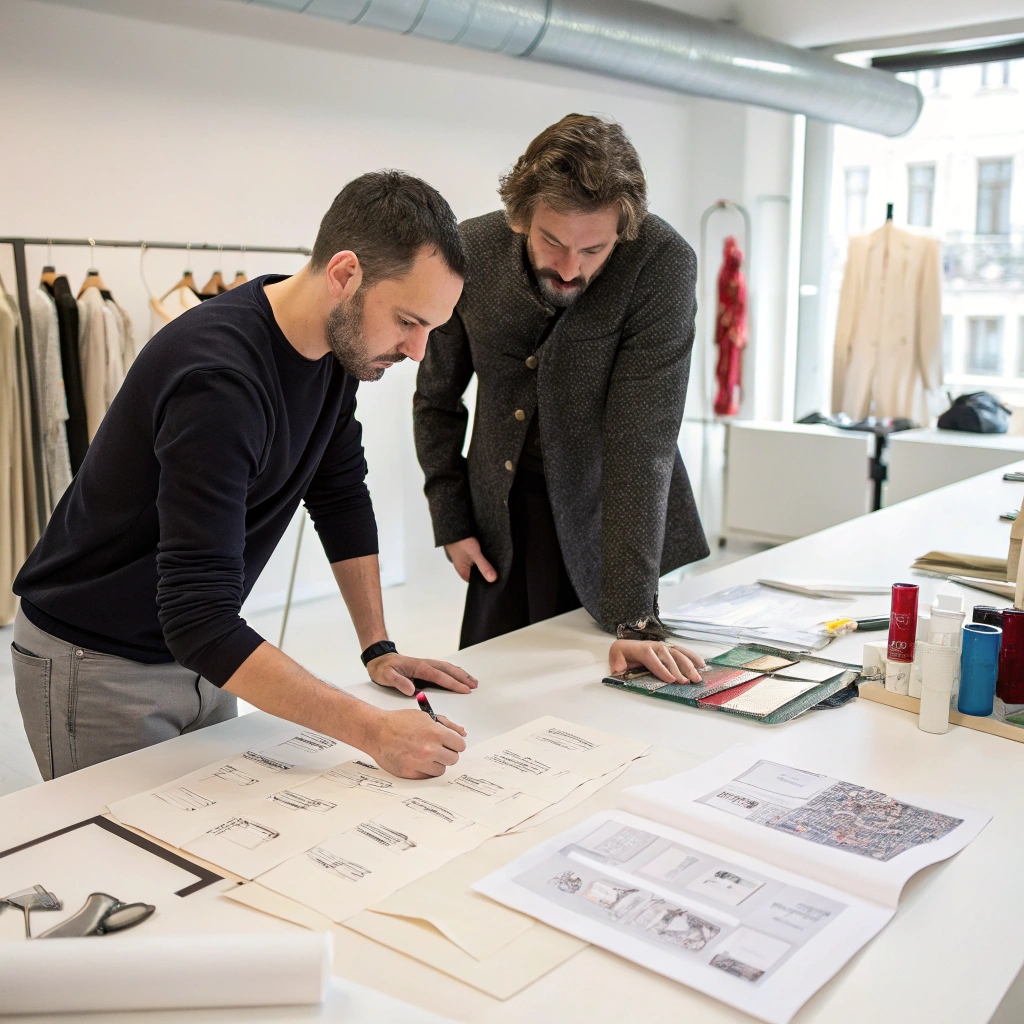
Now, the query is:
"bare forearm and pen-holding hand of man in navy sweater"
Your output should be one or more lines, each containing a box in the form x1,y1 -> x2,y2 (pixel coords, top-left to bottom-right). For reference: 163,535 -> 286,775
223,641 -> 475,778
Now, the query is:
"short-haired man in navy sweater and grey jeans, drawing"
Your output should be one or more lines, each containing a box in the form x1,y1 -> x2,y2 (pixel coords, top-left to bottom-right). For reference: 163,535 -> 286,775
13,171 -> 476,778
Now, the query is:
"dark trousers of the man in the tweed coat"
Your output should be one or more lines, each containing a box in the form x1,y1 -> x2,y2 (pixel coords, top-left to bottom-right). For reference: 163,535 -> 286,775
459,465 -> 581,648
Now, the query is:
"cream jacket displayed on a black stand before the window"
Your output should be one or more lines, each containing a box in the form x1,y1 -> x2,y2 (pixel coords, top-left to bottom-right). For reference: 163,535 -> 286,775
831,221 -> 942,426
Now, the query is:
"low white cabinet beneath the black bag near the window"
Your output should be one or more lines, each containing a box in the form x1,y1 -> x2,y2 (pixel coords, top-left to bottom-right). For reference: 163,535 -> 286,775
882,428 -> 1024,512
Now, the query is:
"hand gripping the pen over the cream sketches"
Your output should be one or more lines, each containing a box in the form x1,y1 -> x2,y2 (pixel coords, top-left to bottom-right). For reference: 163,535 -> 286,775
366,708 -> 466,778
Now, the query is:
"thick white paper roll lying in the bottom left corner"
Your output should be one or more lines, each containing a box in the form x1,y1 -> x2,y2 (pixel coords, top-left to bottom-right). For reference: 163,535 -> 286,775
0,932 -> 334,1014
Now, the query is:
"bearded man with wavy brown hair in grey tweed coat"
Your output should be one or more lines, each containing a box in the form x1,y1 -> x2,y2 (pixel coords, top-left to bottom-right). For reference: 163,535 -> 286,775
414,114 -> 708,678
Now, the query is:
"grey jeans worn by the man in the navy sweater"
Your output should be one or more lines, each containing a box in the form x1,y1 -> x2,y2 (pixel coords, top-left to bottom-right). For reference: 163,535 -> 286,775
11,610 -> 238,779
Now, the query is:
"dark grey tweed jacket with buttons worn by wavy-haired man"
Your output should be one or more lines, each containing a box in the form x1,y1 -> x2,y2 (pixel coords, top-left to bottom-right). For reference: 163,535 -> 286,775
413,211 -> 708,630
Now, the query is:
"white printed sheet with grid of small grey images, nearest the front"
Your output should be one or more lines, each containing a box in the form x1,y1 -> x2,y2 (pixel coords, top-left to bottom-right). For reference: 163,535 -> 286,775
473,811 -> 894,1024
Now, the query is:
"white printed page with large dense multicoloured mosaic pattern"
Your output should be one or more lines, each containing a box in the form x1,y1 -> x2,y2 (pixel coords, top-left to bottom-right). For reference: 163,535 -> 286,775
620,744 -> 991,909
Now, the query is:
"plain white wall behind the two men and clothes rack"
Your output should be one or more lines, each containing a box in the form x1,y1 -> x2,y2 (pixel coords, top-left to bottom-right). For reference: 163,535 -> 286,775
0,0 -> 792,604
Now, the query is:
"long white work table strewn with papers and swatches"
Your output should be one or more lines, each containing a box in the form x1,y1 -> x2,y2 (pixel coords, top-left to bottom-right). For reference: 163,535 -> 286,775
0,470 -> 1024,1024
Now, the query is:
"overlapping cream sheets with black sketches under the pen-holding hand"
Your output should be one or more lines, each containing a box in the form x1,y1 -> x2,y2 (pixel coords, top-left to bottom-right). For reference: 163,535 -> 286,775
110,717 -> 650,923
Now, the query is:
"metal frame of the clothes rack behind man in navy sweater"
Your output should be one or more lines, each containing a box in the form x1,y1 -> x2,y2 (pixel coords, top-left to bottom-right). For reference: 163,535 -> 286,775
0,237 -> 311,641
